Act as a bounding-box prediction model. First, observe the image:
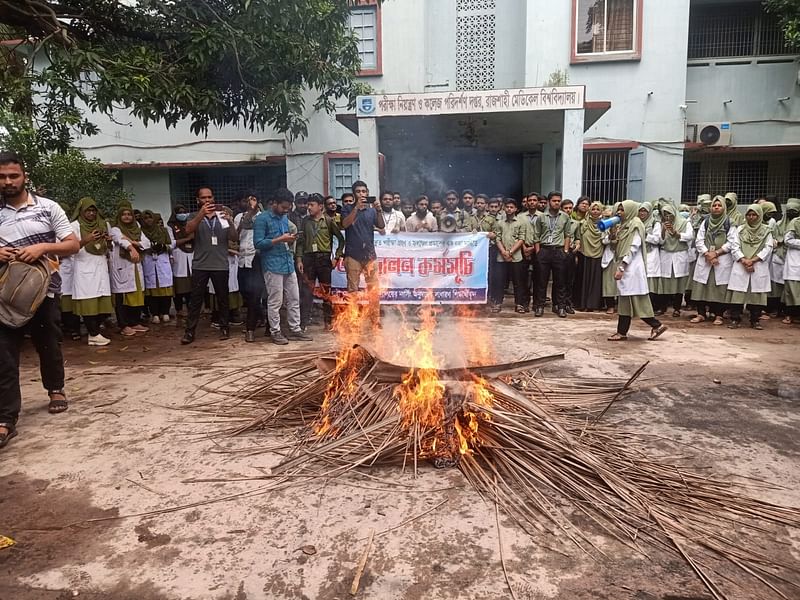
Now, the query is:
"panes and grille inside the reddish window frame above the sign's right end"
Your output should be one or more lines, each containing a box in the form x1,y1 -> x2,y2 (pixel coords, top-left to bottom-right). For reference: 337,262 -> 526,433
575,0 -> 637,54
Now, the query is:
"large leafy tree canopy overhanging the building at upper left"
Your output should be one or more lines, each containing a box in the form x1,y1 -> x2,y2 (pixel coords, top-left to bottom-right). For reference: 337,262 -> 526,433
0,0 -> 367,150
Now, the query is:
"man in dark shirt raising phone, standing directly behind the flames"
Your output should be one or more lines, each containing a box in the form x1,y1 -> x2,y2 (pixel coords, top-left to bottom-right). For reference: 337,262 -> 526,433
342,181 -> 386,325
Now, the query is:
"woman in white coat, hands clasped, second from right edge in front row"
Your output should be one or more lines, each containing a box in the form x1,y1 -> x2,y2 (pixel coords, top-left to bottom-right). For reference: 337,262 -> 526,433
691,196 -> 736,325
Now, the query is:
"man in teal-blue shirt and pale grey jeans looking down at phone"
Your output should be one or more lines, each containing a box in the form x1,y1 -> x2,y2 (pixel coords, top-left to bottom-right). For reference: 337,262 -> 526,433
253,188 -> 312,346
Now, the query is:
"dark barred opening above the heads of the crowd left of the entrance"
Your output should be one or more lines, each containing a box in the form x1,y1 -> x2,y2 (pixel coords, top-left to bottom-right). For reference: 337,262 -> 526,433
169,167 -> 286,212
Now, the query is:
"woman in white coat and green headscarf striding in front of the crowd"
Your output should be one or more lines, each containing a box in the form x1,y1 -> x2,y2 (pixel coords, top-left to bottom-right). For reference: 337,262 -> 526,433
608,200 -> 667,342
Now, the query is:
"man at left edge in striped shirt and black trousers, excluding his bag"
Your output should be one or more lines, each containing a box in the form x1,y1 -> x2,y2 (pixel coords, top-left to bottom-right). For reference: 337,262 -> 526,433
0,152 -> 80,448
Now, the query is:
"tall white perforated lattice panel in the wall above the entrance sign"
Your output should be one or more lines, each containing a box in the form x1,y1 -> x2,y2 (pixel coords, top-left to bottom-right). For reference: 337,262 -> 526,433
456,0 -> 497,90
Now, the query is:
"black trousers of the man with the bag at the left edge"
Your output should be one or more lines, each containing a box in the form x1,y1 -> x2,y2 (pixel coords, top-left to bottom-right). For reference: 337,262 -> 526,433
0,298 -> 64,427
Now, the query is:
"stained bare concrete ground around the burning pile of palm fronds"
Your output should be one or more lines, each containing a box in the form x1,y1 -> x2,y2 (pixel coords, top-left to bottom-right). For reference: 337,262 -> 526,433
0,304 -> 800,600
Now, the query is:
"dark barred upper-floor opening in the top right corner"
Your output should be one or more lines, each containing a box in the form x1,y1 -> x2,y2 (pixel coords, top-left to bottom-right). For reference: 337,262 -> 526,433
689,3 -> 797,60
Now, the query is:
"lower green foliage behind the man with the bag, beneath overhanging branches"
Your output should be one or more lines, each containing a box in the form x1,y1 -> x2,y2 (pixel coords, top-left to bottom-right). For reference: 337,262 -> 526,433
0,112 -> 131,216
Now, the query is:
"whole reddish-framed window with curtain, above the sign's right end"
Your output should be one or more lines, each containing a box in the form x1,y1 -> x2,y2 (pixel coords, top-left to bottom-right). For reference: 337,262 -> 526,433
572,0 -> 642,63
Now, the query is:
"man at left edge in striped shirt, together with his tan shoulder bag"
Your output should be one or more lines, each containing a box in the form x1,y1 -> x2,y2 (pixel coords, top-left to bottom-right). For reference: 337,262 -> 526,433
0,152 -> 80,448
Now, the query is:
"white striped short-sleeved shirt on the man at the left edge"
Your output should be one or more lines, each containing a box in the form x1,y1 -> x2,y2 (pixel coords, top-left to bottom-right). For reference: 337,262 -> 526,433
0,194 -> 73,294
